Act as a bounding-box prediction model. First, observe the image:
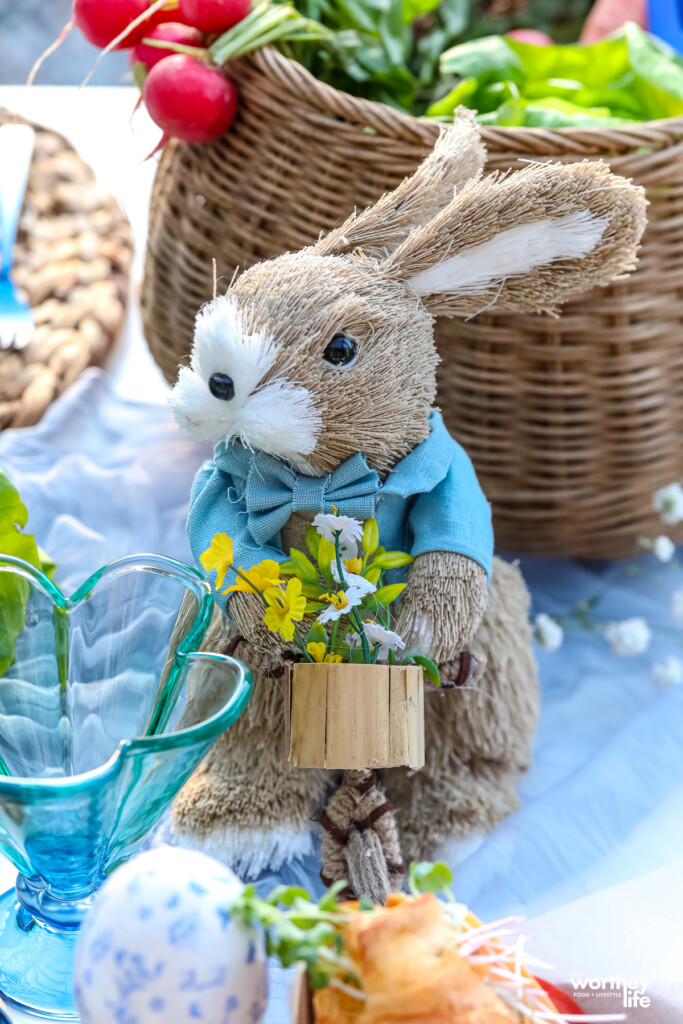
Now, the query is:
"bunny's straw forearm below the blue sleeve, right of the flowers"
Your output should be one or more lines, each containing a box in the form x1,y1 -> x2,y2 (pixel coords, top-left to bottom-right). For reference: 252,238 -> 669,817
394,551 -> 488,664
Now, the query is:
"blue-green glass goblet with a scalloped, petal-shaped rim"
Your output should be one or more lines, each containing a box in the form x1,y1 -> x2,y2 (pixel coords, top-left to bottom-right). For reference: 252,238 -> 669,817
0,555 -> 252,1020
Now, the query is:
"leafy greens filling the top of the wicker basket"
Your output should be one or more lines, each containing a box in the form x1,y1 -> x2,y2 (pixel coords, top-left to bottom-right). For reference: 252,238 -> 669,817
215,0 -> 683,128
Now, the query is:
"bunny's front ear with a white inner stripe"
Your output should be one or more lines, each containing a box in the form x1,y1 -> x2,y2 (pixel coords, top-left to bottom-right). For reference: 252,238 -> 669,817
380,161 -> 647,316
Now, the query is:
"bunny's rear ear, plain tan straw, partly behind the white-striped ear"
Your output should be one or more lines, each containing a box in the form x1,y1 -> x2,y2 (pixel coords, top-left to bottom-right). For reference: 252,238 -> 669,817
314,108 -> 485,258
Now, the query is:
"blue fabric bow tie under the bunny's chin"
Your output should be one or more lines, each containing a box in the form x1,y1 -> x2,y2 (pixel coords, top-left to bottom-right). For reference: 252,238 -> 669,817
214,441 -> 380,545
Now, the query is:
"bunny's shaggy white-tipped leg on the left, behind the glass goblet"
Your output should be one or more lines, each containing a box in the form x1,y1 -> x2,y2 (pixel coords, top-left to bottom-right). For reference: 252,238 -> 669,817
173,633 -> 329,878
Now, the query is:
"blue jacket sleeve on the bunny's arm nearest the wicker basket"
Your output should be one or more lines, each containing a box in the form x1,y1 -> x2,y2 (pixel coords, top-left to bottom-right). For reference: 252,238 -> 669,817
408,439 -> 494,577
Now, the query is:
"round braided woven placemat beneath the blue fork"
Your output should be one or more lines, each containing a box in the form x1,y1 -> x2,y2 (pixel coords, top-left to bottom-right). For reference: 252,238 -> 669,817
0,109 -> 133,429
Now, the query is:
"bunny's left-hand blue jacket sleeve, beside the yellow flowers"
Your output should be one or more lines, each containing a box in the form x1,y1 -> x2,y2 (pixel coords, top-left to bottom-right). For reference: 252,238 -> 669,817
187,460 -> 287,611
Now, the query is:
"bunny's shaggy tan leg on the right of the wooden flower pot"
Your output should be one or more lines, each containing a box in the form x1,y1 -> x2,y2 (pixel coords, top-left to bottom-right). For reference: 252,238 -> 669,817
385,558 -> 539,859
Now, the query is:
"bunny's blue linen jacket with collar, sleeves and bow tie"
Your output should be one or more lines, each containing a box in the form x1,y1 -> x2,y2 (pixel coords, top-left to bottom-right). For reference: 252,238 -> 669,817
187,412 -> 494,609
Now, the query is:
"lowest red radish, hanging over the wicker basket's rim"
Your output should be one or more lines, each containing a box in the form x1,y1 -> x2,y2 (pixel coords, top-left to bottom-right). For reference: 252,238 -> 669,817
142,53 -> 238,142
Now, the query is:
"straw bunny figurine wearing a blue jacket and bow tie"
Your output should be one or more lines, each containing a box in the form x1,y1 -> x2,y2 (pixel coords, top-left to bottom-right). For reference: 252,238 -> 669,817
166,112 -> 645,892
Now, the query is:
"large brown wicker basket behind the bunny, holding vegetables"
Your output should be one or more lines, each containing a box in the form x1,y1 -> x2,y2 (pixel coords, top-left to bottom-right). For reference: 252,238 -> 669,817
142,50 -> 683,558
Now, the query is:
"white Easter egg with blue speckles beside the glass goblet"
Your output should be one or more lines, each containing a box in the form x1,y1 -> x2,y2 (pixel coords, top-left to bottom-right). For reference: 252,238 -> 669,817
74,847 -> 267,1024
